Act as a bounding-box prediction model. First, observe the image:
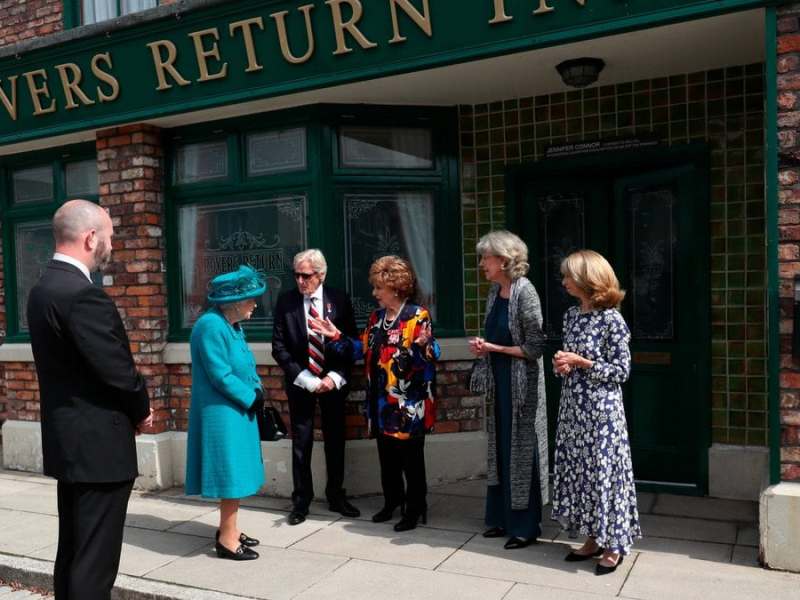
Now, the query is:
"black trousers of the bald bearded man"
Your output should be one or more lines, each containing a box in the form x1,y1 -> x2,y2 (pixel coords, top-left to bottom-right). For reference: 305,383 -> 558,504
53,480 -> 133,600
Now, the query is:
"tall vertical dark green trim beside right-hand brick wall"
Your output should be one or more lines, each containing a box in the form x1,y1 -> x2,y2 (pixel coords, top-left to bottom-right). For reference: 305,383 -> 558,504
764,7 -> 780,485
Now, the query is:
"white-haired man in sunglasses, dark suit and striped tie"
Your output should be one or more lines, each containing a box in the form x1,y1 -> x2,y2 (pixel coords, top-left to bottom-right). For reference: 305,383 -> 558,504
272,249 -> 361,525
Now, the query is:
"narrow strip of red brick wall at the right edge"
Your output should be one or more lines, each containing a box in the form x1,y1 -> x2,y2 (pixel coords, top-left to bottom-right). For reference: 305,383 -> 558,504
777,4 -> 800,481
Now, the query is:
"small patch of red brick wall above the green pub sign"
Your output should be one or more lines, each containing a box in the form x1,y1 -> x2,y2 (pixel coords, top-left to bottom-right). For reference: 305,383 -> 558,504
0,0 -> 64,46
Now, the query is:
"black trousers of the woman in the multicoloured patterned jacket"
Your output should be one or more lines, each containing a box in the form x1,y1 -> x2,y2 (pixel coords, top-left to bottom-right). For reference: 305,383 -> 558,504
377,433 -> 428,515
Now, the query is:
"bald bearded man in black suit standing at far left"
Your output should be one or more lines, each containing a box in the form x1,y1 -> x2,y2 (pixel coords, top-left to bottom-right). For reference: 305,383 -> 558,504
28,200 -> 152,600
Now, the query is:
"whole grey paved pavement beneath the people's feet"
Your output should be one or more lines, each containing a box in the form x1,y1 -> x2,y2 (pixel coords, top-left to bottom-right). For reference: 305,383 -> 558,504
0,471 -> 800,600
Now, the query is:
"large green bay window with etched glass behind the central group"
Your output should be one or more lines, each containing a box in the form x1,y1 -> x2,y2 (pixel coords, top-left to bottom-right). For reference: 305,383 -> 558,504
166,105 -> 463,341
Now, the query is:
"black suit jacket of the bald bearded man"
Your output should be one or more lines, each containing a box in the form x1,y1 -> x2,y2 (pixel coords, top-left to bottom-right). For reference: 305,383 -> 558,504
28,260 -> 150,483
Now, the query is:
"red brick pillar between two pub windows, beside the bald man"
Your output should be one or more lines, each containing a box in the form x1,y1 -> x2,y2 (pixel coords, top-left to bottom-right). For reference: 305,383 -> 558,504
96,125 -> 173,433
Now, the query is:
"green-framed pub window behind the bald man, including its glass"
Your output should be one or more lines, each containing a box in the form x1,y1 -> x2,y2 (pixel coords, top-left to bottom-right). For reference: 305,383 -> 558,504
0,145 -> 98,342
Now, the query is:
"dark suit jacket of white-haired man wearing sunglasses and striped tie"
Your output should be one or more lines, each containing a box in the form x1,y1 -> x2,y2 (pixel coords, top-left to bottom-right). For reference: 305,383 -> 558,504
272,285 -> 358,390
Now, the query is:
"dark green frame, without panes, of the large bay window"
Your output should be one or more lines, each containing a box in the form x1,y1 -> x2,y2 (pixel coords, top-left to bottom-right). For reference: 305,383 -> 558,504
165,105 -> 464,342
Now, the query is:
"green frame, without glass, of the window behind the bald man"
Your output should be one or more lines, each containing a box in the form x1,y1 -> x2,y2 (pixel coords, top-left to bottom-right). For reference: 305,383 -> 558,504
0,143 -> 99,343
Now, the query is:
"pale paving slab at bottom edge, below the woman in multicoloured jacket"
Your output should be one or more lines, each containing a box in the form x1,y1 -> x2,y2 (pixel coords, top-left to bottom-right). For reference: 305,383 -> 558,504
295,560 -> 514,600
